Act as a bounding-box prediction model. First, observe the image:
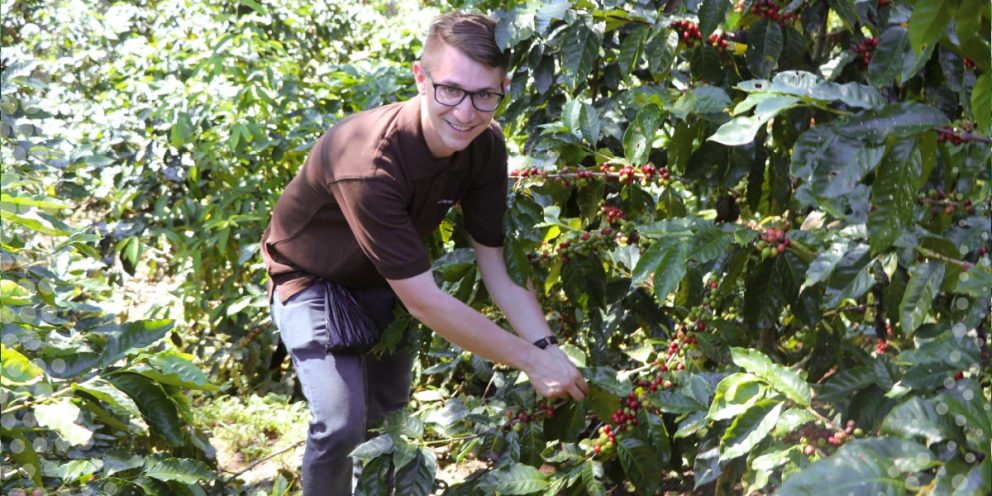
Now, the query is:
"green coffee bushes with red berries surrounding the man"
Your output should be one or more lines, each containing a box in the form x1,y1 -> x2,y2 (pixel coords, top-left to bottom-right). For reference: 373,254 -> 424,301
0,0 -> 992,494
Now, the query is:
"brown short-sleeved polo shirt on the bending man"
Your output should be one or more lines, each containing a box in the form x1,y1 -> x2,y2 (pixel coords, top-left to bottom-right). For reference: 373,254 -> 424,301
261,96 -> 507,302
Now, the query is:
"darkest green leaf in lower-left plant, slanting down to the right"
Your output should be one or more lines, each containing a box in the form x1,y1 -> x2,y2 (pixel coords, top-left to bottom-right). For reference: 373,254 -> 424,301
107,372 -> 185,447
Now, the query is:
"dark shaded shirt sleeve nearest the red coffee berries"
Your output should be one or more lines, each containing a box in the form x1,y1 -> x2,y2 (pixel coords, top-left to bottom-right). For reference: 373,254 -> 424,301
461,130 -> 507,247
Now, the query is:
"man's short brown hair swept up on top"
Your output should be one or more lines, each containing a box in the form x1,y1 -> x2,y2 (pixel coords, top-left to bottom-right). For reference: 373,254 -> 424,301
420,12 -> 510,72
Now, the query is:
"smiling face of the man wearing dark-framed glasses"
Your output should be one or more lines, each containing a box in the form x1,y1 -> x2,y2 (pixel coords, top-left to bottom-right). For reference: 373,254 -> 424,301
413,43 -> 509,157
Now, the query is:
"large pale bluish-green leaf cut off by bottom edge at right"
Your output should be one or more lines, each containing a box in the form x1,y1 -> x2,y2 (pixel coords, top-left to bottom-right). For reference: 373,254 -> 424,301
778,437 -> 940,496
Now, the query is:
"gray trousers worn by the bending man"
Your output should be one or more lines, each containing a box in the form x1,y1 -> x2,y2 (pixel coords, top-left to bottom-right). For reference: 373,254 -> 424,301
271,283 -> 413,496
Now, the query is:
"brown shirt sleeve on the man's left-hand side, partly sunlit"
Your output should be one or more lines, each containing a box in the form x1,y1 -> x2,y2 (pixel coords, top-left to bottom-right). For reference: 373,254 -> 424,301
328,177 -> 430,279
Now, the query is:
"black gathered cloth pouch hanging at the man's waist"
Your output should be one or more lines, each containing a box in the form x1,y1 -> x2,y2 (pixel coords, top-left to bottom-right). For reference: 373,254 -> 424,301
319,281 -> 395,354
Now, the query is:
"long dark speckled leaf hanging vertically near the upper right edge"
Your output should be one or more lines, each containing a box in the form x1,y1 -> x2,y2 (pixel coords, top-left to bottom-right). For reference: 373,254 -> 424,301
868,140 -> 923,253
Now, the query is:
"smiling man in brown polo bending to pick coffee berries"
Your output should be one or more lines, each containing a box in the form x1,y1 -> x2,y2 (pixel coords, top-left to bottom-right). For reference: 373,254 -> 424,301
262,13 -> 588,495
